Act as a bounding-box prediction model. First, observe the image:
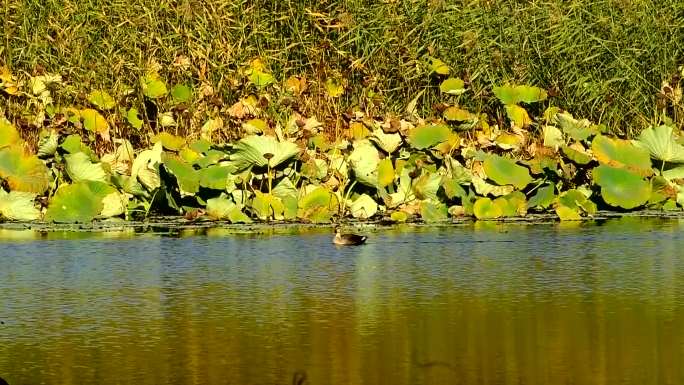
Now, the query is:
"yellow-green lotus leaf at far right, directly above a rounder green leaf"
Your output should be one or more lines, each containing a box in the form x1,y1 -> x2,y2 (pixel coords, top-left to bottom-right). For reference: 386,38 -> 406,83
591,135 -> 653,176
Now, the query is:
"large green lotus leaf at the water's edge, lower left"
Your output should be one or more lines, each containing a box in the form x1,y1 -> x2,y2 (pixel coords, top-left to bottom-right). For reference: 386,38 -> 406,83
45,181 -> 116,223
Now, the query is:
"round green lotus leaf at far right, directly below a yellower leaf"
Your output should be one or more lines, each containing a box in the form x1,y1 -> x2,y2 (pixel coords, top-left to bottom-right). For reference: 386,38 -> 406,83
593,165 -> 651,209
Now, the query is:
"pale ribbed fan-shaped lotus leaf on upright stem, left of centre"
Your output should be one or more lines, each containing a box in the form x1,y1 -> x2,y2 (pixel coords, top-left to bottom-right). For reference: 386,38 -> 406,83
230,135 -> 300,171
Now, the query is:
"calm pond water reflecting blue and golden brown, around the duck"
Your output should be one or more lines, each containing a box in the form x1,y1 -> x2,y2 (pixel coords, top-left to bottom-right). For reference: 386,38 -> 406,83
0,219 -> 684,385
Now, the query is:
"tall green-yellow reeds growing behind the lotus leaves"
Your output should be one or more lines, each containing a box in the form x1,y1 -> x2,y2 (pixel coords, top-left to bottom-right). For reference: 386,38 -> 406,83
0,0 -> 684,135
